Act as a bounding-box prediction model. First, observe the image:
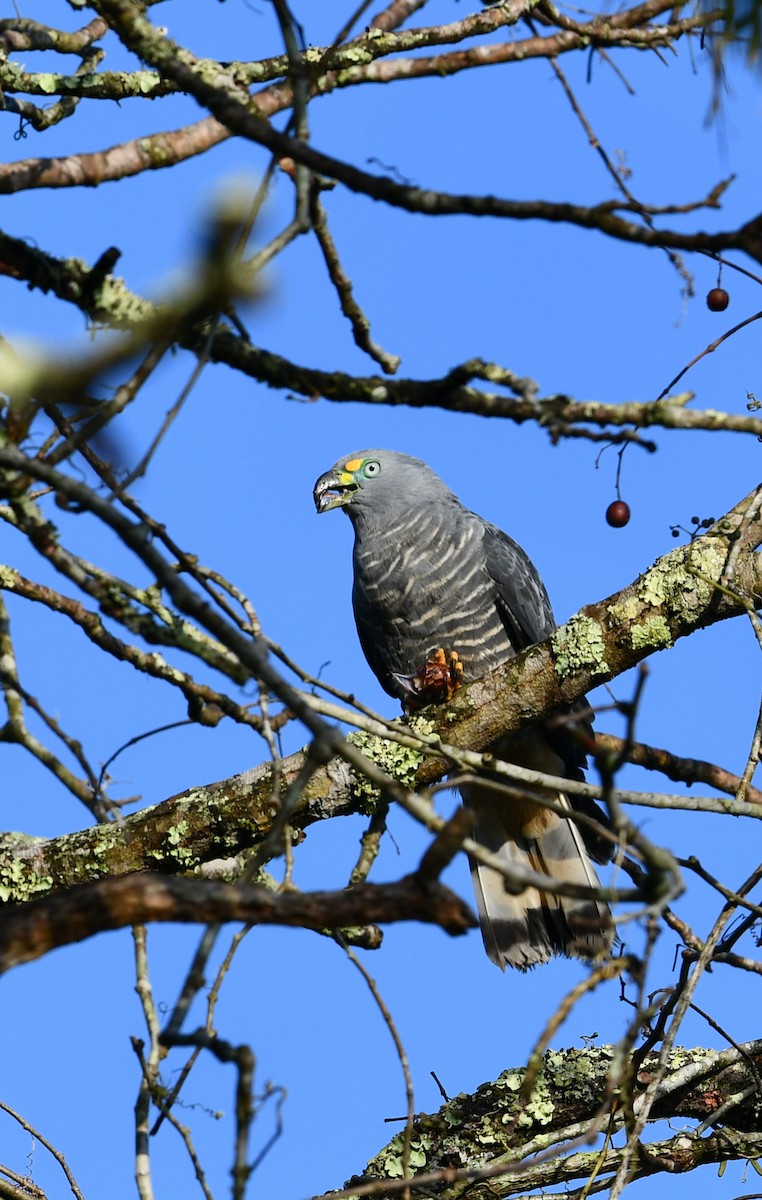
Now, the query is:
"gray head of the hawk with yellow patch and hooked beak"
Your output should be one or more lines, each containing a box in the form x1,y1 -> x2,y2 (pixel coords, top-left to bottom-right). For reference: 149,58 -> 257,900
313,450 -> 455,521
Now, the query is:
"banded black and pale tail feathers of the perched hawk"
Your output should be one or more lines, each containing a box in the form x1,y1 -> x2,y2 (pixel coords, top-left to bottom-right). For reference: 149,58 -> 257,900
464,786 -> 613,970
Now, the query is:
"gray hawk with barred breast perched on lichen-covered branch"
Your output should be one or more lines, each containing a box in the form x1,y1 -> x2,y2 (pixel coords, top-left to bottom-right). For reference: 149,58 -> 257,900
314,450 -> 612,970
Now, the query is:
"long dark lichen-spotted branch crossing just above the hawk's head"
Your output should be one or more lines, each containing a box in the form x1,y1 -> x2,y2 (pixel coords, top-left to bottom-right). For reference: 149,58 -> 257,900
0,219 -> 762,439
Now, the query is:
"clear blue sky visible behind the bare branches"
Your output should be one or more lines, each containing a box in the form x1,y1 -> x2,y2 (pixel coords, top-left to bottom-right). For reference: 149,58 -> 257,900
0,0 -> 762,1200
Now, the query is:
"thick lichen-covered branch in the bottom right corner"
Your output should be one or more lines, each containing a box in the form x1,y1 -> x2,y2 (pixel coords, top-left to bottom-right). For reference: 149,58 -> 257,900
330,1042 -> 762,1200
